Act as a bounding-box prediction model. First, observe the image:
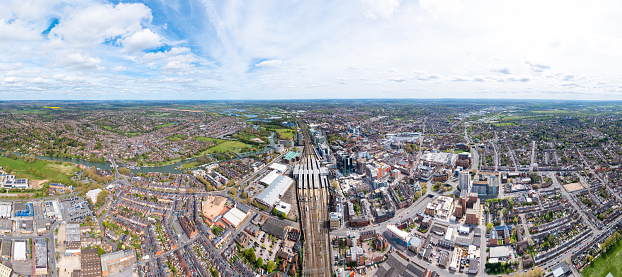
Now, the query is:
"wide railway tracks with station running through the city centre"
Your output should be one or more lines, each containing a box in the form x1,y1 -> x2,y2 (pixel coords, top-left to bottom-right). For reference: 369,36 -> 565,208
294,116 -> 332,277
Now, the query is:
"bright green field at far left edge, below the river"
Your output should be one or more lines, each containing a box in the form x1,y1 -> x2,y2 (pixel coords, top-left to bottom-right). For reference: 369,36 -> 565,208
0,156 -> 77,184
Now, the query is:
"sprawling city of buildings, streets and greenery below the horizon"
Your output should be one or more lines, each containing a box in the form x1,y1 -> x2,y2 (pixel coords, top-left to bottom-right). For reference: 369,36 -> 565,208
0,100 -> 622,277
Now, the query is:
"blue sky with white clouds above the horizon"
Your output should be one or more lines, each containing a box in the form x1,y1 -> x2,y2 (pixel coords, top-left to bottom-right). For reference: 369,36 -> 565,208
0,0 -> 622,100
